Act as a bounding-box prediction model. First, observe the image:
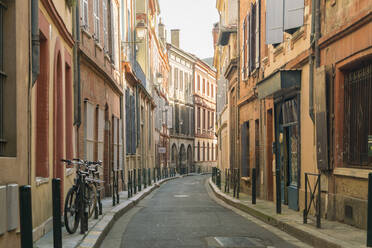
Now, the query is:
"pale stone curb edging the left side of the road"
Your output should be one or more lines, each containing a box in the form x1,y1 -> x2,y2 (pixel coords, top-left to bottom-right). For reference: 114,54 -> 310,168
75,176 -> 182,248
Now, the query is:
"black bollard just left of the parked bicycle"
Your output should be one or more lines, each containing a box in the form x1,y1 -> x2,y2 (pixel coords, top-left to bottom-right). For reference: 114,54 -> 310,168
52,178 -> 62,248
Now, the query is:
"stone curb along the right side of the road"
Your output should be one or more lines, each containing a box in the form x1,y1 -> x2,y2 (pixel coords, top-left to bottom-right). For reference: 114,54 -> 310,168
208,179 -> 344,248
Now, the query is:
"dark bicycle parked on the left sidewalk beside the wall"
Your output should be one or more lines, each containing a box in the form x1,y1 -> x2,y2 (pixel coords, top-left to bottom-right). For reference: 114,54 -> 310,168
61,159 -> 102,234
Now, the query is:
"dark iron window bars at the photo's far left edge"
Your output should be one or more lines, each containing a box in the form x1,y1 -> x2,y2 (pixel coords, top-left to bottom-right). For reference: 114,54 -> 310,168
0,1 -> 6,156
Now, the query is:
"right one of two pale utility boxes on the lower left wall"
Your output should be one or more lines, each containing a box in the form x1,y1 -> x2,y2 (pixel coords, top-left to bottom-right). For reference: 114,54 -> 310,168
6,184 -> 19,231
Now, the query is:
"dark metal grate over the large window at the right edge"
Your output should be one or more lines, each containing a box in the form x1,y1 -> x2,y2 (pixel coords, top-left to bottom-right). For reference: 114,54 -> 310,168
344,62 -> 372,166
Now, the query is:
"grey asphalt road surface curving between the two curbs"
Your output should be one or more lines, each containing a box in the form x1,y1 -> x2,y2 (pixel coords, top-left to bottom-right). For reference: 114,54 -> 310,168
101,176 -> 306,248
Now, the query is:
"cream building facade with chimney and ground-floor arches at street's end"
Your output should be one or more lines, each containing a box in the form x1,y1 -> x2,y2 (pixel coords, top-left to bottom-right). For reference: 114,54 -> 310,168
167,30 -> 195,174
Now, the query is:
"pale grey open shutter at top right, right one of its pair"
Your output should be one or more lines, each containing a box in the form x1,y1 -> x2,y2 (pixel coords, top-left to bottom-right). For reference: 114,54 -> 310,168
284,0 -> 305,30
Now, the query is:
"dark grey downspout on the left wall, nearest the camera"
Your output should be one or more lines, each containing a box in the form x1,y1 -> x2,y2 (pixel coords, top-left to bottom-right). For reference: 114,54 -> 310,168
27,0 -> 40,185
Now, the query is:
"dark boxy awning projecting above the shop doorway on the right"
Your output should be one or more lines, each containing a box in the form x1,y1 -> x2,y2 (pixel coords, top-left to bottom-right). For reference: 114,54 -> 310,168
257,70 -> 301,99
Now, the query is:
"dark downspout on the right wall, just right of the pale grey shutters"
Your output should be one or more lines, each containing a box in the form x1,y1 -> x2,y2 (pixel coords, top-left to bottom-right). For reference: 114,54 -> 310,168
309,0 -> 318,123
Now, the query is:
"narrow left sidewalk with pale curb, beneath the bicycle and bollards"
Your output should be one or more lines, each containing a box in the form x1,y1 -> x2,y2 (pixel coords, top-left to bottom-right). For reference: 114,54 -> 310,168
34,176 -> 182,248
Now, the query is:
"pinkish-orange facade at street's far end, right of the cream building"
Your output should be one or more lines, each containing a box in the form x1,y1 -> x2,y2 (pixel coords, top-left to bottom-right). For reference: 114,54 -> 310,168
193,59 -> 217,172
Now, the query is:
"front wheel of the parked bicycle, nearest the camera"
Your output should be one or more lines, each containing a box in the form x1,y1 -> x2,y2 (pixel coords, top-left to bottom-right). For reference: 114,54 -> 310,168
64,187 -> 79,234
